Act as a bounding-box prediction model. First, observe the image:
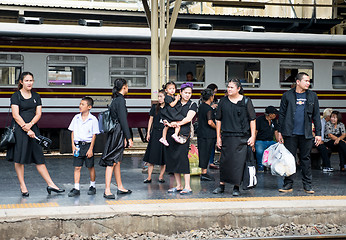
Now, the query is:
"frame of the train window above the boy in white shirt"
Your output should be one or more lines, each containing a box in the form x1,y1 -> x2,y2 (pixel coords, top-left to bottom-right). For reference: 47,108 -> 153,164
46,54 -> 89,88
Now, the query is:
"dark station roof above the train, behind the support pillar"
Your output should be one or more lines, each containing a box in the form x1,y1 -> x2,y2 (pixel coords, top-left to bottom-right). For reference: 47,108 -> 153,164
0,0 -> 342,34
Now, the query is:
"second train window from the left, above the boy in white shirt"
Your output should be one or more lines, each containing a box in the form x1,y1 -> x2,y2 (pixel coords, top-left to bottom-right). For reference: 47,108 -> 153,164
47,55 -> 88,86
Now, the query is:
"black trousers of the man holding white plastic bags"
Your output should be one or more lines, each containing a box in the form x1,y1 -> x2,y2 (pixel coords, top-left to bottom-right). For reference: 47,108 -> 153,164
284,135 -> 313,189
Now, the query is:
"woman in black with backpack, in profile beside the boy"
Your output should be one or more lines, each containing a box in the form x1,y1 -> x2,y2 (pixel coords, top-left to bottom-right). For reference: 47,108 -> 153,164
99,78 -> 133,199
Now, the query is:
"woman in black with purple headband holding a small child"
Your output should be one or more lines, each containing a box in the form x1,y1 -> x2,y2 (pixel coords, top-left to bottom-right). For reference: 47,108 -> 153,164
164,83 -> 197,195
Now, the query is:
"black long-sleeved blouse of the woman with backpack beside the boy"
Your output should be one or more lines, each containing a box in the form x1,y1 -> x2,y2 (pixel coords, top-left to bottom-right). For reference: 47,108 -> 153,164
110,94 -> 131,139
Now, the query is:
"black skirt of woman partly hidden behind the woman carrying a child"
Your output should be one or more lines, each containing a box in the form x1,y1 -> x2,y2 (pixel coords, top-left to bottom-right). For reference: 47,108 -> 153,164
143,128 -> 166,165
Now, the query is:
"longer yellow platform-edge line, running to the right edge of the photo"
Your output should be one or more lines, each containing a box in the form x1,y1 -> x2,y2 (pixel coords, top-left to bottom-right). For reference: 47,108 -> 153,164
106,196 -> 346,205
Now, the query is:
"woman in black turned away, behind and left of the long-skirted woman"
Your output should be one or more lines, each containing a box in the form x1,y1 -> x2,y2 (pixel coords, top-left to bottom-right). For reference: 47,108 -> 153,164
197,88 -> 216,181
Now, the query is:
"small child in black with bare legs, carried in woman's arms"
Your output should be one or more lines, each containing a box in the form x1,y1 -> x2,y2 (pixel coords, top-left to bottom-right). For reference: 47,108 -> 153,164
159,81 -> 186,146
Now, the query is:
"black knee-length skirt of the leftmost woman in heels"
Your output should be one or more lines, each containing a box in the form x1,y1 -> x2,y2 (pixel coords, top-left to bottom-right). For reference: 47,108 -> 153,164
6,122 -> 46,164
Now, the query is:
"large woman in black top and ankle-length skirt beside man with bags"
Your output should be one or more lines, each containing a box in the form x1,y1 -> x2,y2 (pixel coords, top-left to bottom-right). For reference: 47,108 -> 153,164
213,79 -> 256,196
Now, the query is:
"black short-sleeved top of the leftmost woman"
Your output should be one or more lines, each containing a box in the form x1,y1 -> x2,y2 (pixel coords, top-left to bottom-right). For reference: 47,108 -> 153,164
11,91 -> 42,123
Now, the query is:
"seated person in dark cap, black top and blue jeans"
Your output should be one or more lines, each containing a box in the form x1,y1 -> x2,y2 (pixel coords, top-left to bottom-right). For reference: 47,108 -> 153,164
255,106 -> 278,172
